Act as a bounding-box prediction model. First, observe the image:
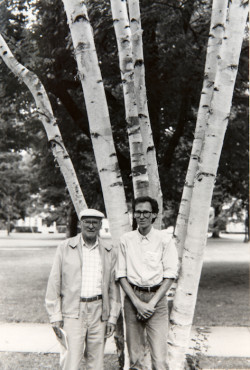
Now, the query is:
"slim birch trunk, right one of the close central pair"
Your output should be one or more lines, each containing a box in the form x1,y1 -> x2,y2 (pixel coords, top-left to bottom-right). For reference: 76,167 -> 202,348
128,0 -> 163,229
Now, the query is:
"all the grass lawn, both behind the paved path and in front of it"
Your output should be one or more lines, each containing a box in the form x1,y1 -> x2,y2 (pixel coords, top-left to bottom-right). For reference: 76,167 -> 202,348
0,236 -> 250,370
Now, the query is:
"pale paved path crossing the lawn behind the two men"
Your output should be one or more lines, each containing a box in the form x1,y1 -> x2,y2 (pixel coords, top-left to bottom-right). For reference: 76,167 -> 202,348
0,323 -> 250,358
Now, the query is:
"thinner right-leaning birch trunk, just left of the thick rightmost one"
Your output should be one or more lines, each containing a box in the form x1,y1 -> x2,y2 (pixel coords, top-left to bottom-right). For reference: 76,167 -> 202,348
174,0 -> 227,259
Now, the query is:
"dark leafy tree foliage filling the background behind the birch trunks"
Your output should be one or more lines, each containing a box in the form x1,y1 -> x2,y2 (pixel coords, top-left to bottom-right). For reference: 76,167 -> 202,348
0,0 -> 248,226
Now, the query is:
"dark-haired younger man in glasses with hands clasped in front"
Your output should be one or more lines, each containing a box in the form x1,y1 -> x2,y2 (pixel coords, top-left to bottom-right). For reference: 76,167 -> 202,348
116,197 -> 178,370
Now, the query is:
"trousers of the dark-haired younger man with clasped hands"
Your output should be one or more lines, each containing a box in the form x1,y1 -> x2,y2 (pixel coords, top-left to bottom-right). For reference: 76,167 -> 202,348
124,290 -> 168,370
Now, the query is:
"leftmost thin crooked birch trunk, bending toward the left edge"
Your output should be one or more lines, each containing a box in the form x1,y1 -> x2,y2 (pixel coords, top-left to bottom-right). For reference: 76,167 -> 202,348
0,35 -> 87,215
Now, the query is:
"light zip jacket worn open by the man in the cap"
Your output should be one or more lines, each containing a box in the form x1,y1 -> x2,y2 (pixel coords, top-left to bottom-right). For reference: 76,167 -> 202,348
45,234 -> 121,324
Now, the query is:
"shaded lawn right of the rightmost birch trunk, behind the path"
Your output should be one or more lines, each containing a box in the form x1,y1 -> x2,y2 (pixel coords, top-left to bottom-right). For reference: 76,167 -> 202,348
193,262 -> 250,326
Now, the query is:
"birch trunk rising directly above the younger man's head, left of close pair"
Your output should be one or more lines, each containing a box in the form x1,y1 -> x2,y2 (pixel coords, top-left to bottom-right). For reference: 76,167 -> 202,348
110,0 -> 149,197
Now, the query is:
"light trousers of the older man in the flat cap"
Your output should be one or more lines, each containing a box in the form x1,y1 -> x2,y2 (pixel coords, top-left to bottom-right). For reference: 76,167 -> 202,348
60,300 -> 107,370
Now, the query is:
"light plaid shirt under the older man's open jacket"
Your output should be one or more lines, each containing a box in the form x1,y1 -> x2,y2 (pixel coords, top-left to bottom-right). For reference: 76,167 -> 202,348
81,238 -> 102,298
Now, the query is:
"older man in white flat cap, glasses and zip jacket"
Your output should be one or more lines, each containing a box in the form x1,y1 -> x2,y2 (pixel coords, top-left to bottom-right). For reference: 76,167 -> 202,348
45,209 -> 120,370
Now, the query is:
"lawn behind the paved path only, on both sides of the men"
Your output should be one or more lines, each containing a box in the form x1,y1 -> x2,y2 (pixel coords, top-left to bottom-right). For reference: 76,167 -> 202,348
0,238 -> 250,326
